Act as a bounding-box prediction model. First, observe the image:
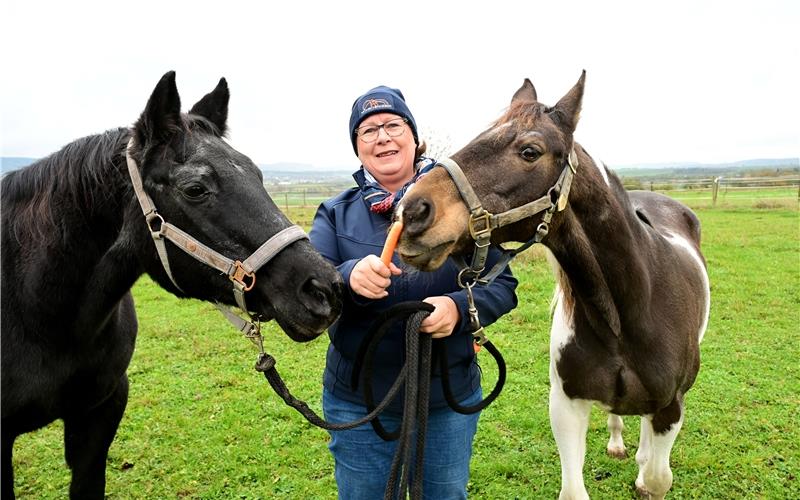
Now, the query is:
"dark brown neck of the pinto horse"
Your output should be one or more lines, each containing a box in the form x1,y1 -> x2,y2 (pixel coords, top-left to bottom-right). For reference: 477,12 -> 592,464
547,157 -> 649,338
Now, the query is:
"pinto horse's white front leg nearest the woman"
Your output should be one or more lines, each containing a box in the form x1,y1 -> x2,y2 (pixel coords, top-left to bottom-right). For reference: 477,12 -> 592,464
550,376 -> 592,499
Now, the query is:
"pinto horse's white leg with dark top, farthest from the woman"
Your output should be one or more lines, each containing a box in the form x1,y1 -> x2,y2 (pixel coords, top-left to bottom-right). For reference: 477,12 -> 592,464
636,399 -> 683,500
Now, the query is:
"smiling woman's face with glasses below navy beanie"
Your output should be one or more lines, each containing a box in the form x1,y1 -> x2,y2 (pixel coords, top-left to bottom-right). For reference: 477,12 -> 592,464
356,113 -> 417,193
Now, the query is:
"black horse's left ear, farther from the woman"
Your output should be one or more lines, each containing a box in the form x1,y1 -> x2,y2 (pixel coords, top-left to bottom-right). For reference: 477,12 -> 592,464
135,71 -> 182,146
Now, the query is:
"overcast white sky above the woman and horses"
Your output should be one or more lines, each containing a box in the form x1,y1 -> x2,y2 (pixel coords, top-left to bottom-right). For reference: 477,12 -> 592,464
0,0 -> 800,169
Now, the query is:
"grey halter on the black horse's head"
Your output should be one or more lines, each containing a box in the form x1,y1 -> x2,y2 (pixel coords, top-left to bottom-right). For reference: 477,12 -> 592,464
125,138 -> 308,346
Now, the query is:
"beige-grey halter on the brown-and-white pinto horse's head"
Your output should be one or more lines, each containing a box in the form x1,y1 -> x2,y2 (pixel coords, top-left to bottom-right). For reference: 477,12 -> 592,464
437,149 -> 578,288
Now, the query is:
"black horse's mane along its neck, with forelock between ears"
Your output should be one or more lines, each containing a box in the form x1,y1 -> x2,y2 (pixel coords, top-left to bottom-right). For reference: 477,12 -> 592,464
2,114 -> 220,247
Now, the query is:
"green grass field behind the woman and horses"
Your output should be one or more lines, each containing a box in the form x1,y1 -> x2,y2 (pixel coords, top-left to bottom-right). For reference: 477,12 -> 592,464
9,204 -> 800,499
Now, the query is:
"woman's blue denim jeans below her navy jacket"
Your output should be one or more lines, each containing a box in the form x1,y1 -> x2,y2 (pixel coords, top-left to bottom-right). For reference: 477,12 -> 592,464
322,389 -> 482,500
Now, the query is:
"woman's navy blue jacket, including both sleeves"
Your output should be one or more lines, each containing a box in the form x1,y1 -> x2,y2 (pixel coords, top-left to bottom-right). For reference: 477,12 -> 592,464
309,166 -> 517,412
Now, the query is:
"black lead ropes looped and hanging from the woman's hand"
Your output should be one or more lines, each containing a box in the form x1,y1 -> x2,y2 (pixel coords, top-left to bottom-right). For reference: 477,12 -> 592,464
256,301 -> 506,500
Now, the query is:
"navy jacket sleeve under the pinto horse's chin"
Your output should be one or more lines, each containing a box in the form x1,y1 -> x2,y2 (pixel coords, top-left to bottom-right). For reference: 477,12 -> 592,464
446,247 -> 517,334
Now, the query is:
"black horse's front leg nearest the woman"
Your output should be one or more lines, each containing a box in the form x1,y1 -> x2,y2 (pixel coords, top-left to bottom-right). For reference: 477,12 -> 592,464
64,374 -> 128,498
